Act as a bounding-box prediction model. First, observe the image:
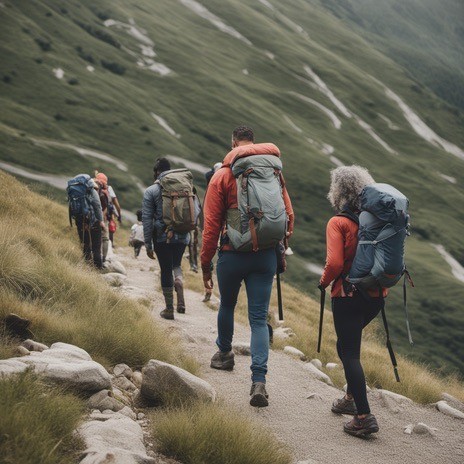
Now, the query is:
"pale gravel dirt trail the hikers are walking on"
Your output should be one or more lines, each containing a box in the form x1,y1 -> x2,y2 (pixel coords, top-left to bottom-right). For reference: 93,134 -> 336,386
116,248 -> 464,464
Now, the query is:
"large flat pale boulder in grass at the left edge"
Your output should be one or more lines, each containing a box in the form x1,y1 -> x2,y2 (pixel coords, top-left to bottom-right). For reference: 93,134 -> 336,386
0,343 -> 111,391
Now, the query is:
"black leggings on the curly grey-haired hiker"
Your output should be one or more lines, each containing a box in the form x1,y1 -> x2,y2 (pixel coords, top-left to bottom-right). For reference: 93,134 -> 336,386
332,292 -> 384,414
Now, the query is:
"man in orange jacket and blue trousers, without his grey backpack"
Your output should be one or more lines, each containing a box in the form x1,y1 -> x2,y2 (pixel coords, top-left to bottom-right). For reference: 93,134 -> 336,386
201,126 -> 294,406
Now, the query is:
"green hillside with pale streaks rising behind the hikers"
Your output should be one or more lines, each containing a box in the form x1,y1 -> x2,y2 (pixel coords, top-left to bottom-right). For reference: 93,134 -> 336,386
0,0 -> 464,373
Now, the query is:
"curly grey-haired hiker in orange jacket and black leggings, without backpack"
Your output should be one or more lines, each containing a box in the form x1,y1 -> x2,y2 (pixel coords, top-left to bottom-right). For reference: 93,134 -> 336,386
319,166 -> 387,436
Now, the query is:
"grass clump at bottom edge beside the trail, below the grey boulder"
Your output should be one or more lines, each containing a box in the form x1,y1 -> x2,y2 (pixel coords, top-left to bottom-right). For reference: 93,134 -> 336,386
151,403 -> 292,464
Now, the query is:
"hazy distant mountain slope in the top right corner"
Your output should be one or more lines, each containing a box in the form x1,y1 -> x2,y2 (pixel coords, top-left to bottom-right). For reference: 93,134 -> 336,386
316,0 -> 464,111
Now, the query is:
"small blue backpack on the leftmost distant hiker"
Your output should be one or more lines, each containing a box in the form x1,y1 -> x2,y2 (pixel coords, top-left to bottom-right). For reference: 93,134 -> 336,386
66,174 -> 95,226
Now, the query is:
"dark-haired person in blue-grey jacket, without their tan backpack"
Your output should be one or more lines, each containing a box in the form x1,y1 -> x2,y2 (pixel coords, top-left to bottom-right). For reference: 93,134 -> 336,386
142,158 -> 190,319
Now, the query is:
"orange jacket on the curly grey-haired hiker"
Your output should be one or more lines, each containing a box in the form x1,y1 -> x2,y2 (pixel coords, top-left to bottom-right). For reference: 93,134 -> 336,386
321,216 -> 387,298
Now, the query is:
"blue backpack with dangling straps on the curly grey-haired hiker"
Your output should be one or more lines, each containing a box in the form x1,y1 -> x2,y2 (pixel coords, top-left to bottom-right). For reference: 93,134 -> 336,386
348,184 -> 414,382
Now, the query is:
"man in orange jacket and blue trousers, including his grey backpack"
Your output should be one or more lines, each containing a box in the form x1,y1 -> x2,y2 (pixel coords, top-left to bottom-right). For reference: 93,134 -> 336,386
201,126 -> 294,406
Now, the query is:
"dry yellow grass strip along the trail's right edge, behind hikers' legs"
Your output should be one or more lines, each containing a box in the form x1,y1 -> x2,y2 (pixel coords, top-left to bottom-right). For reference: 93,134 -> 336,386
187,256 -> 464,404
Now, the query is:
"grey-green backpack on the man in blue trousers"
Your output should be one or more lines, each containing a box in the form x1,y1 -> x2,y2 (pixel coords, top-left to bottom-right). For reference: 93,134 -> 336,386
227,155 -> 287,251
